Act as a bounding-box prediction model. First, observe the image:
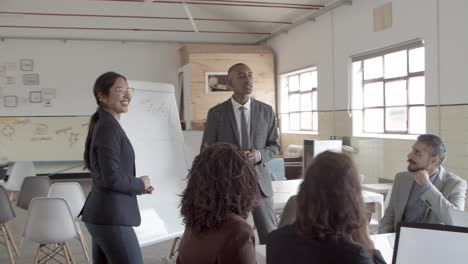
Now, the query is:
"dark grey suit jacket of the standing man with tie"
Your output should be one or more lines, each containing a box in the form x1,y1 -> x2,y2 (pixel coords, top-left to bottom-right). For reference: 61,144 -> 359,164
201,98 -> 280,197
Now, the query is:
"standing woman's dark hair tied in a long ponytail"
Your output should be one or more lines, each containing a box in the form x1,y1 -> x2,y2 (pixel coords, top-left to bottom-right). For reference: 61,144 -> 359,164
84,72 -> 127,170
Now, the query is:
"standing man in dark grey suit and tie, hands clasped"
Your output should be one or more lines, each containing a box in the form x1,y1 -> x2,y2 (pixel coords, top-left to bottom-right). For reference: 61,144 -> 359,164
202,63 -> 280,244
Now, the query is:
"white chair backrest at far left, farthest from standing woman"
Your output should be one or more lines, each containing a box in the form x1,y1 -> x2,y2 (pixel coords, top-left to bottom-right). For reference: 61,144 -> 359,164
2,161 -> 36,192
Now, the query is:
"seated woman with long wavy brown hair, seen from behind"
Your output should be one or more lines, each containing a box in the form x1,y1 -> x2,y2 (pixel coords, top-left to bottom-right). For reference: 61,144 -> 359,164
266,151 -> 385,264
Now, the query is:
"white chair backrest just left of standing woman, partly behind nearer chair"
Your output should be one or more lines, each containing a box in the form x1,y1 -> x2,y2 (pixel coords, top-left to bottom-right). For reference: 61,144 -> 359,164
47,182 -> 85,218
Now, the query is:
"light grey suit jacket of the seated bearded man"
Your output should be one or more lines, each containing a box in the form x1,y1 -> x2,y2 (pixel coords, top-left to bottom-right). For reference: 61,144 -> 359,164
379,166 -> 467,233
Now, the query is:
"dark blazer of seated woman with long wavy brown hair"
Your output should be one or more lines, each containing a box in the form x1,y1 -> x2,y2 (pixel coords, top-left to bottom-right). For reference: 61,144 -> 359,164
266,225 -> 386,264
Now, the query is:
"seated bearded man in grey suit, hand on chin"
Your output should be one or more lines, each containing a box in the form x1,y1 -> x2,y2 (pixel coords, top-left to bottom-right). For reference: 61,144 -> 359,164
379,134 -> 467,233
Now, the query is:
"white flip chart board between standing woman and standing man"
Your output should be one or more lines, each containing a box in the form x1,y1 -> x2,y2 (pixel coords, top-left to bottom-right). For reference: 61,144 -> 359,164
120,81 -> 188,246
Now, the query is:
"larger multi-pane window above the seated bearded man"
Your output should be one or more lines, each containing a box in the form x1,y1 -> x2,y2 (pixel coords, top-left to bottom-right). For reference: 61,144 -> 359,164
352,41 -> 426,138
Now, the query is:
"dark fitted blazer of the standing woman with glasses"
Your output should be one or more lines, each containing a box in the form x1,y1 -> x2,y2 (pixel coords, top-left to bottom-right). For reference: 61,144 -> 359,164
82,110 -> 145,226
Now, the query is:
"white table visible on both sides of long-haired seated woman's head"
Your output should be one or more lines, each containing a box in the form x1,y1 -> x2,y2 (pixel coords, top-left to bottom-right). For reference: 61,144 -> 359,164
271,179 -> 384,221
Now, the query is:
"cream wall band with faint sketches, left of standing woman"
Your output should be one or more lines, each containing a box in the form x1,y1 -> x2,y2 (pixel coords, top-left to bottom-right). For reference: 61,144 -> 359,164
0,116 -> 89,163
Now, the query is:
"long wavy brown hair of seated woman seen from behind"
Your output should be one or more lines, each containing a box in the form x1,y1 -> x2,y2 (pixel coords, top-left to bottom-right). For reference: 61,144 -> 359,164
296,151 -> 373,250
